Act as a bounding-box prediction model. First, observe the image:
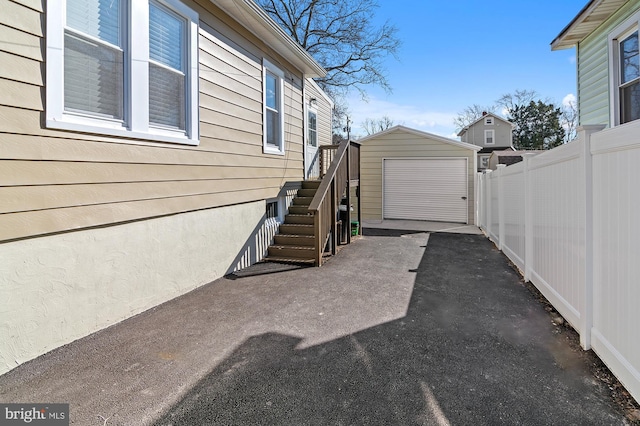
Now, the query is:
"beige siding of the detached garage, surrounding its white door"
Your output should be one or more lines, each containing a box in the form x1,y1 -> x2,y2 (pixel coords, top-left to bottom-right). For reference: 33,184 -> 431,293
360,131 -> 476,223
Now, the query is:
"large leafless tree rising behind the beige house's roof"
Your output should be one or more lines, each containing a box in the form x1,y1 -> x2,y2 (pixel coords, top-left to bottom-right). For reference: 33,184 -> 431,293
258,0 -> 400,100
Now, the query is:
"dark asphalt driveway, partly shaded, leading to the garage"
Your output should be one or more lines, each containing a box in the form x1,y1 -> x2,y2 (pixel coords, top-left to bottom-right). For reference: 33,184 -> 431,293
0,229 -> 625,425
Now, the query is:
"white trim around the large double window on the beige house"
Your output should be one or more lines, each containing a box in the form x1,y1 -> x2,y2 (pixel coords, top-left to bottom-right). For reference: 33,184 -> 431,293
46,0 -> 200,145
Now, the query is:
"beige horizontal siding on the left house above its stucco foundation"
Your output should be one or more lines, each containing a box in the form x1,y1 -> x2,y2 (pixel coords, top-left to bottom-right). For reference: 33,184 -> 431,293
0,0 -> 303,241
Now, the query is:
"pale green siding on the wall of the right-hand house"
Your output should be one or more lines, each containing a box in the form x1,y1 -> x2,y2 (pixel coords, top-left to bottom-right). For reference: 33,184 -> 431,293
577,1 -> 640,126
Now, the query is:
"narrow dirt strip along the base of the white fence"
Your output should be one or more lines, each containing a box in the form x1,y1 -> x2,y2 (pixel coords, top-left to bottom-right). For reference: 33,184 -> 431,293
514,278 -> 640,425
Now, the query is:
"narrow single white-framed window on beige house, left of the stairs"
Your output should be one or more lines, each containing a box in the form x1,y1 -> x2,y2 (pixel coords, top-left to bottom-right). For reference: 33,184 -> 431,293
263,59 -> 284,155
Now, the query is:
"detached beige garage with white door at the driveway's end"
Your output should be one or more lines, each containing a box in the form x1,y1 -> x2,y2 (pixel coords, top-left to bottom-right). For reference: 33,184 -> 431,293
358,126 -> 480,223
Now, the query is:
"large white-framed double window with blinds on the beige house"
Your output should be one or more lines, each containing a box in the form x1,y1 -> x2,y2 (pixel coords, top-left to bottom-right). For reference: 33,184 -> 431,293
46,0 -> 199,145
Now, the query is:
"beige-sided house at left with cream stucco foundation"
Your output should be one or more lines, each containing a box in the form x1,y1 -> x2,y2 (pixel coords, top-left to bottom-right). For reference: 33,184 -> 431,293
0,0 -> 331,374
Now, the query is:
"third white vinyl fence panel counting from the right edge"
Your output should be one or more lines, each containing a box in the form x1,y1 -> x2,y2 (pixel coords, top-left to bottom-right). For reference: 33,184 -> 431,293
499,163 -> 525,272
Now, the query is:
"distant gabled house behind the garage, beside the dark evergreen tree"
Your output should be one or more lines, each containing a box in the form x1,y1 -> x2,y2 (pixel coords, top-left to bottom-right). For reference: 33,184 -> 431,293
458,112 -> 513,172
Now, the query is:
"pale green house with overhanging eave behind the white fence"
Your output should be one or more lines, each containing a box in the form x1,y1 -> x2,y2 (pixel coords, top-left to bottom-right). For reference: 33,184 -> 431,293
551,0 -> 640,127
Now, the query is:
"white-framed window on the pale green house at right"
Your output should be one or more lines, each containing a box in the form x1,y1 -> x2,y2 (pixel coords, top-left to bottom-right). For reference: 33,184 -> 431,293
609,13 -> 640,125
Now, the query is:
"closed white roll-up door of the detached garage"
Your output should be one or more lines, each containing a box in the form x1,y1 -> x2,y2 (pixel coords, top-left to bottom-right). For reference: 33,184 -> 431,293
383,158 -> 468,223
